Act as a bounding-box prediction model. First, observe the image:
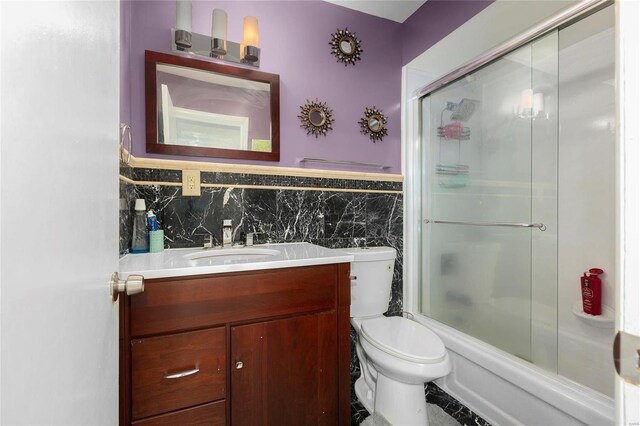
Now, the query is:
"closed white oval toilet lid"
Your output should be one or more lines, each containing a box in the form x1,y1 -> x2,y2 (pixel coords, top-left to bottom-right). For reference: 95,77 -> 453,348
360,317 -> 446,364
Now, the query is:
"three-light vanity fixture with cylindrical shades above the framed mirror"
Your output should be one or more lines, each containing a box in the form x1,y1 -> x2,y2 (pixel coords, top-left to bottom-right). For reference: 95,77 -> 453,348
171,0 -> 260,67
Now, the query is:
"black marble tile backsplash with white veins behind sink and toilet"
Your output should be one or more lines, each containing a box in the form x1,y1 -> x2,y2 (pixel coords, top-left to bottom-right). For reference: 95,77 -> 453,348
120,169 -> 403,315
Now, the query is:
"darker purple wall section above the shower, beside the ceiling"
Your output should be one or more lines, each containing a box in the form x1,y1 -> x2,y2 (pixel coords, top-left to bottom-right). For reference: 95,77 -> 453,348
402,0 -> 494,65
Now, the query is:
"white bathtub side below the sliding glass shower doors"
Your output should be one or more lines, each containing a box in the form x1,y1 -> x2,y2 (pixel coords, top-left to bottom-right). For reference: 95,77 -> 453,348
415,315 -> 615,426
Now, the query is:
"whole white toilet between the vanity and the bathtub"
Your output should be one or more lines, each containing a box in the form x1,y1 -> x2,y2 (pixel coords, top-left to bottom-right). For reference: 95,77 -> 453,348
342,247 -> 451,426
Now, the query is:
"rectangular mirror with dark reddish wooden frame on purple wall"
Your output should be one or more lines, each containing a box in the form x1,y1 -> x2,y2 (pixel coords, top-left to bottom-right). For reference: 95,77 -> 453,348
145,51 -> 280,161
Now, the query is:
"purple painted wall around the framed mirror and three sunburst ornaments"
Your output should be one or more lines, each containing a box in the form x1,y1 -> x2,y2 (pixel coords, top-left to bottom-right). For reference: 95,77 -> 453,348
126,0 -> 491,173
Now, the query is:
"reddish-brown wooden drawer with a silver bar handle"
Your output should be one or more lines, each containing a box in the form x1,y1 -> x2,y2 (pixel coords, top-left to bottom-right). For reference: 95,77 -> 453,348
131,327 -> 226,420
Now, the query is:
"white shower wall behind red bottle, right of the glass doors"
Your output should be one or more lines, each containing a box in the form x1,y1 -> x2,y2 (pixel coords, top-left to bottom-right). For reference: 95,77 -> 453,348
558,7 -> 616,397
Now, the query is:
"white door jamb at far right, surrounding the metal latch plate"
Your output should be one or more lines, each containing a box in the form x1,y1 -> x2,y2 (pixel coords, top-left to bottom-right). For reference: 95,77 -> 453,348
615,1 -> 640,425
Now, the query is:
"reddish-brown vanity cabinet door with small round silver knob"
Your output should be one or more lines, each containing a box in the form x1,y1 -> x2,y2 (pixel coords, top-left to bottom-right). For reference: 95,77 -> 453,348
231,311 -> 338,426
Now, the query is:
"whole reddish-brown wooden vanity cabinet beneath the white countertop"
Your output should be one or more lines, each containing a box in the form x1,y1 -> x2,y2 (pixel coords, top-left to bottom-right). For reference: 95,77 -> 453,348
120,263 -> 350,426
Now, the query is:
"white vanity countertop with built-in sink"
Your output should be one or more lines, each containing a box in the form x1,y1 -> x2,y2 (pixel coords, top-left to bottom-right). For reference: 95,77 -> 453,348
120,243 -> 353,279
